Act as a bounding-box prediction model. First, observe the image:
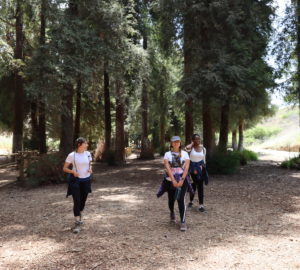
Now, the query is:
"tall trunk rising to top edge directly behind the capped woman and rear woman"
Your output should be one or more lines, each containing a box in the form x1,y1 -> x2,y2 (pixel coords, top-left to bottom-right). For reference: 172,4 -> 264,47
183,4 -> 194,144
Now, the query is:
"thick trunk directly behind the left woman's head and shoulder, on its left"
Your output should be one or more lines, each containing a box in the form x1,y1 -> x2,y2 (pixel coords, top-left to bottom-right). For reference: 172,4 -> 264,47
59,84 -> 73,156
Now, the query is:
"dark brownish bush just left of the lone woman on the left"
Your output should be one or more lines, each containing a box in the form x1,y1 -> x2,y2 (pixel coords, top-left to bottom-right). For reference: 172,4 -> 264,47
25,153 -> 65,186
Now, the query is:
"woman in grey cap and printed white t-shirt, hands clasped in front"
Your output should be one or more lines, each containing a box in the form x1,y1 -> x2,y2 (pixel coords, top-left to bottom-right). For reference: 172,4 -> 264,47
164,136 -> 190,231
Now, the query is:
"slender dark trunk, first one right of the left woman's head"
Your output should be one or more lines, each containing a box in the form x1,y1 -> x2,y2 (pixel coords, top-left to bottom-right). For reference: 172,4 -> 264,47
103,66 -> 111,160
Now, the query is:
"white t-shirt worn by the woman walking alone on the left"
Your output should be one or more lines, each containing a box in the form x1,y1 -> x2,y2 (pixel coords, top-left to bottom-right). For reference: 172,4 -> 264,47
66,151 -> 92,178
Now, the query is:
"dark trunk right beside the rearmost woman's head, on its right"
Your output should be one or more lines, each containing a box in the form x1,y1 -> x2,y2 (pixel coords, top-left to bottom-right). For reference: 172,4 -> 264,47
202,97 -> 214,158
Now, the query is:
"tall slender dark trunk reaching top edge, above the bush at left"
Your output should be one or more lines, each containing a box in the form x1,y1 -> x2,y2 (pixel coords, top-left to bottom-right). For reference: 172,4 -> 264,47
38,0 -> 47,153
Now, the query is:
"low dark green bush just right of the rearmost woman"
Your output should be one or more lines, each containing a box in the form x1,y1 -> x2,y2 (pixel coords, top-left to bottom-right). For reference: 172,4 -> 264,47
207,152 -> 240,174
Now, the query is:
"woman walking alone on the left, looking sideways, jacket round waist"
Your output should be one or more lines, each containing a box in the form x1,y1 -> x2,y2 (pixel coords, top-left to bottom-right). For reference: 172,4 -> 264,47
63,138 -> 92,233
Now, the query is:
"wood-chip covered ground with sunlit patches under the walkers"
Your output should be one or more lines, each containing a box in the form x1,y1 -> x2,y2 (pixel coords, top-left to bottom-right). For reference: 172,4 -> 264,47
0,155 -> 300,270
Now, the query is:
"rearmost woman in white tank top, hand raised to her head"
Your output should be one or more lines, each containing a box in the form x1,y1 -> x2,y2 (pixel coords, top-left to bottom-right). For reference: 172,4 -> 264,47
185,134 -> 208,212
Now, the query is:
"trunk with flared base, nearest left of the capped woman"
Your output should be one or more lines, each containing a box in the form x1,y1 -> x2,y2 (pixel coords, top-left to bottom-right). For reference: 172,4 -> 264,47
140,33 -> 154,159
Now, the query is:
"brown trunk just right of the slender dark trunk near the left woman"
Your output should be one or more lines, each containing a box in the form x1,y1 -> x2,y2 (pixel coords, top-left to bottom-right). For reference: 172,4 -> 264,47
115,80 -> 125,164
